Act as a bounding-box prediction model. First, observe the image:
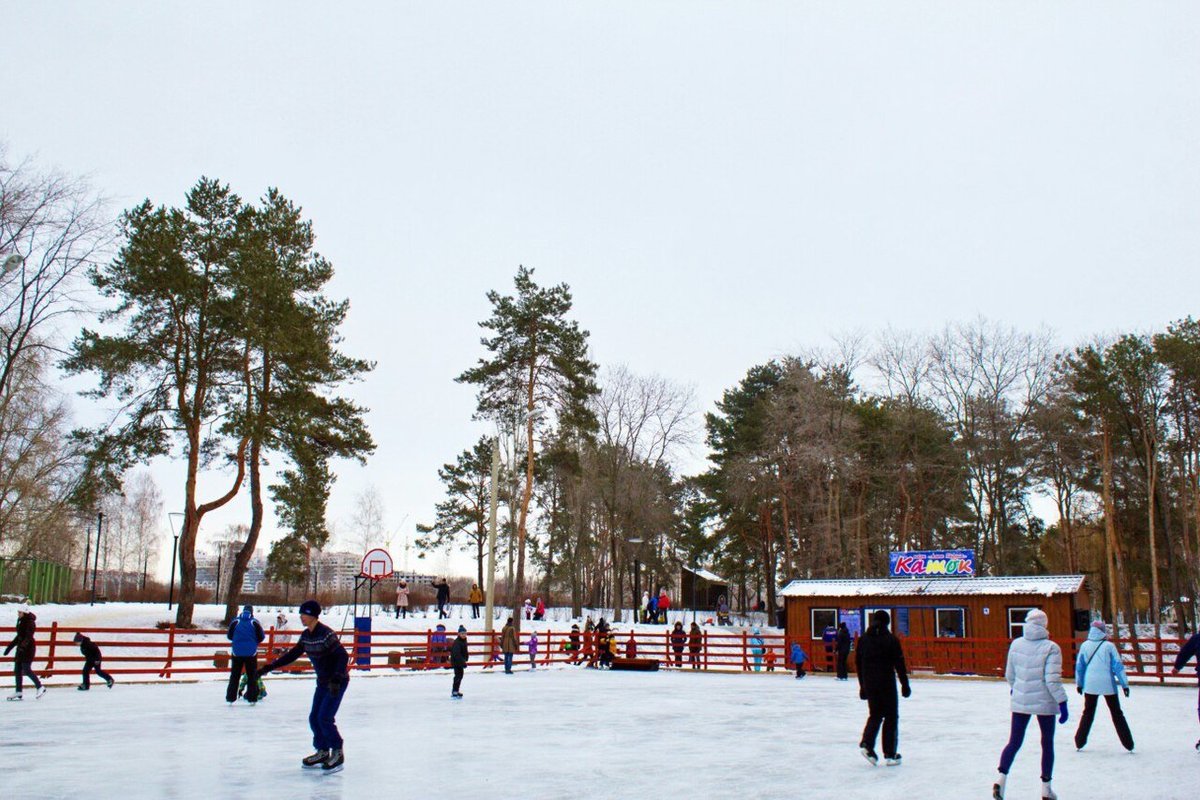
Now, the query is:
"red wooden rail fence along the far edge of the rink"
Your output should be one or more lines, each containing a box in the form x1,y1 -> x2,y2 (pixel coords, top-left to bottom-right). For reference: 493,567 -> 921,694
0,622 -> 1195,682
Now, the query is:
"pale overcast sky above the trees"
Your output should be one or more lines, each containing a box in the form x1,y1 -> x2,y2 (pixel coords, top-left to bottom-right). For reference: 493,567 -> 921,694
0,0 -> 1200,573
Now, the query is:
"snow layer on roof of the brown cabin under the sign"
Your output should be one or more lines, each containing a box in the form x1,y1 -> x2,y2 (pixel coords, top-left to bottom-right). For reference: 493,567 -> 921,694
779,575 -> 1084,597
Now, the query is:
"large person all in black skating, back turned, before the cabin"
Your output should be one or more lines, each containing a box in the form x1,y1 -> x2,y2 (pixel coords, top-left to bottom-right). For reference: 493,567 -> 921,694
854,609 -> 912,766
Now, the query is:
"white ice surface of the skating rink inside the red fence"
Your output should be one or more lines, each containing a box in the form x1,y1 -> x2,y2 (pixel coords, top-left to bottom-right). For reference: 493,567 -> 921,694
0,667 -> 1200,800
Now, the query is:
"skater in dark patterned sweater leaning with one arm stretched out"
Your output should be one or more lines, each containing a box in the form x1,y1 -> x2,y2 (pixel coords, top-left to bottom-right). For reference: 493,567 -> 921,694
262,600 -> 350,774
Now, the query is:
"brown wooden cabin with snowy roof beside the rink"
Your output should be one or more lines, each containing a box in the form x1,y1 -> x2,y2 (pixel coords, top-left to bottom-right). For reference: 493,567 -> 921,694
780,575 -> 1091,674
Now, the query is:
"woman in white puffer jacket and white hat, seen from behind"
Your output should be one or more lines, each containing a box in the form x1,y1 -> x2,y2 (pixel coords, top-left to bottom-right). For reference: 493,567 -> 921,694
992,608 -> 1067,800
